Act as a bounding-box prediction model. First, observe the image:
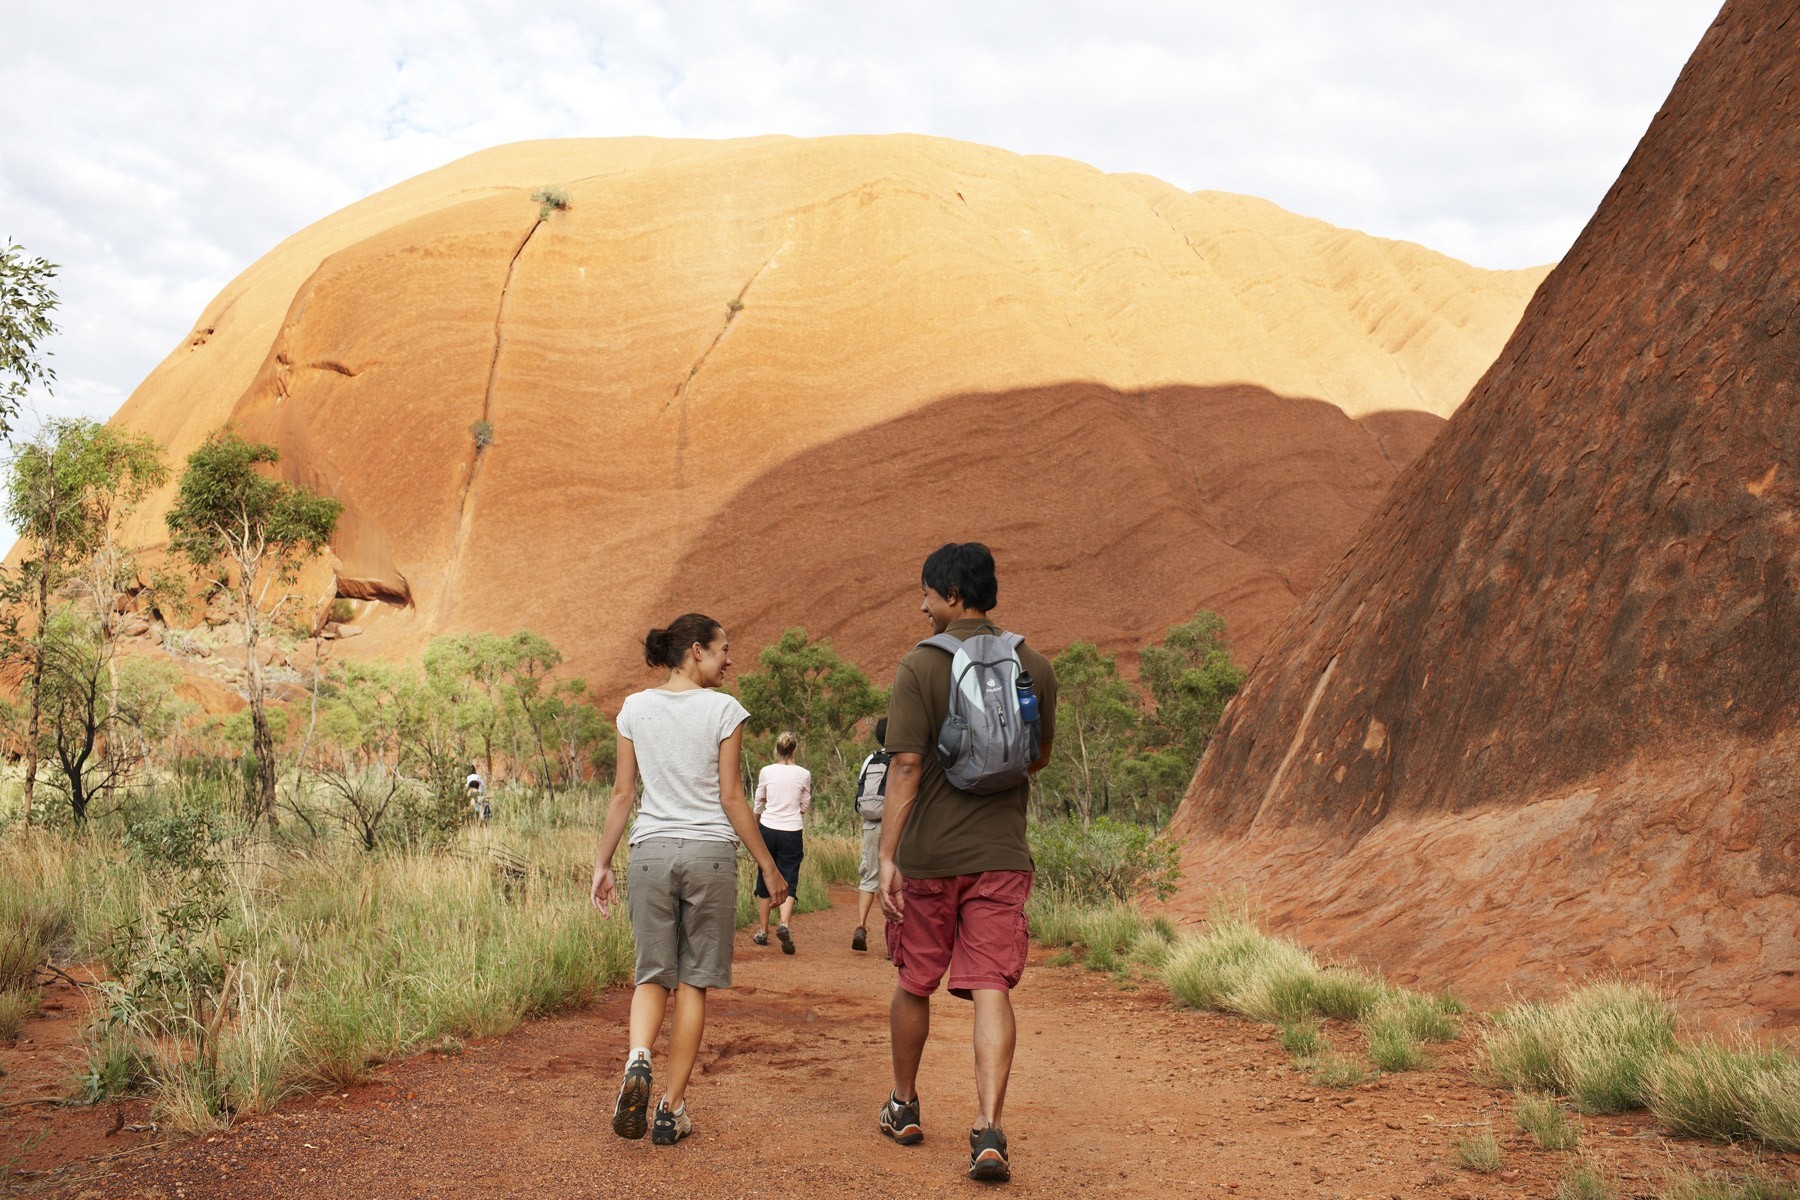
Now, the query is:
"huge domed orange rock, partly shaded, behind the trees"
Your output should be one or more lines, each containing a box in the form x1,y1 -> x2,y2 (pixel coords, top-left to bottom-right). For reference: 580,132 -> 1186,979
91,137 -> 1543,700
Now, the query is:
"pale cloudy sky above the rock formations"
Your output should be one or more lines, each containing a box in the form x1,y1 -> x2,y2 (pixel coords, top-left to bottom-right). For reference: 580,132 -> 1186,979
0,0 -> 1717,431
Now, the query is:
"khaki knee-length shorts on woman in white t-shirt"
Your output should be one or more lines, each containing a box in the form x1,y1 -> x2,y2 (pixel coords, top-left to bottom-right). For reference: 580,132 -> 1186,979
625,837 -> 738,988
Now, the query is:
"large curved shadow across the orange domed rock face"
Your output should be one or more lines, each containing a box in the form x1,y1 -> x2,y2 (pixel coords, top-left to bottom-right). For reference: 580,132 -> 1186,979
661,381 -> 1444,680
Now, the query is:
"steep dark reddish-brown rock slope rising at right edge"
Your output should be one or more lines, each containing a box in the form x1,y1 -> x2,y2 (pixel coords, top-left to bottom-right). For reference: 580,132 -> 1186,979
1175,0 -> 1800,1025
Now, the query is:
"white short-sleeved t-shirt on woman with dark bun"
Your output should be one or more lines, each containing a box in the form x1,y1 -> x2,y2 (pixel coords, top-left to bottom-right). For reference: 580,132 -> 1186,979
617,687 -> 751,846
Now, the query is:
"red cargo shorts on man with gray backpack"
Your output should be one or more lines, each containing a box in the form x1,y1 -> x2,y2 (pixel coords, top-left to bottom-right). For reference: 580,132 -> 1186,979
887,871 -> 1031,1000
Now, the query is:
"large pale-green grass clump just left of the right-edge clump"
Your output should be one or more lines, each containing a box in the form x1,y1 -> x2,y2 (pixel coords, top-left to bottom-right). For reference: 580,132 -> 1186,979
1485,981 -> 1676,1112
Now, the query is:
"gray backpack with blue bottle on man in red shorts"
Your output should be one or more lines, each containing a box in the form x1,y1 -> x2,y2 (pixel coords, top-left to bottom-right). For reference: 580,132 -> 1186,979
920,633 -> 1042,795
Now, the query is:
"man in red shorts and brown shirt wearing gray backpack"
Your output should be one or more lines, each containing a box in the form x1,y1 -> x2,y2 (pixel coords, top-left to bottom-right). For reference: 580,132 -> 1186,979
878,542 -> 1057,1182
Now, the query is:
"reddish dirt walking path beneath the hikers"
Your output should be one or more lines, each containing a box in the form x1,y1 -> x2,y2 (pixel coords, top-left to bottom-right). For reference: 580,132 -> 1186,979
0,889 -> 1800,1200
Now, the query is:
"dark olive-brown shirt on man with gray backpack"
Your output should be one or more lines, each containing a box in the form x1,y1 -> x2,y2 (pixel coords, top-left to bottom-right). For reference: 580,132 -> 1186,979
887,621 -> 1057,880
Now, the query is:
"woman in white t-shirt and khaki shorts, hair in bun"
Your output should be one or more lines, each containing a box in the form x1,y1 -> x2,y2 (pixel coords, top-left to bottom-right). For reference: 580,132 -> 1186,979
592,612 -> 787,1146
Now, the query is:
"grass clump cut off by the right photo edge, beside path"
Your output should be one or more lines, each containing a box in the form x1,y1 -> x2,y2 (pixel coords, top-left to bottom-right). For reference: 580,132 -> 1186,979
1649,1040 -> 1800,1150
